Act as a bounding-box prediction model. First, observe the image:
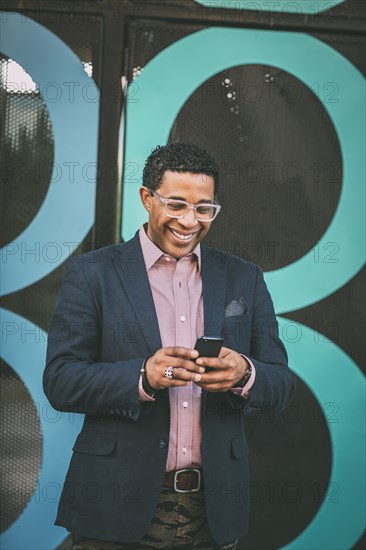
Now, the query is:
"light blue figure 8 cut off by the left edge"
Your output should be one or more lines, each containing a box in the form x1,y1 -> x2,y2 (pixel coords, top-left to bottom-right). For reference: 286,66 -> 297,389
0,12 -> 99,550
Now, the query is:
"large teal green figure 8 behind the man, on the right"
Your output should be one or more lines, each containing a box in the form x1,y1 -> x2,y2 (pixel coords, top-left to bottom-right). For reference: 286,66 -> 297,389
122,28 -> 365,550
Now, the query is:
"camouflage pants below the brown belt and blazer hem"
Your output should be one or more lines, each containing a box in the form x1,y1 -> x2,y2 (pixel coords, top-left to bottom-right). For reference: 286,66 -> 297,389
72,488 -> 237,550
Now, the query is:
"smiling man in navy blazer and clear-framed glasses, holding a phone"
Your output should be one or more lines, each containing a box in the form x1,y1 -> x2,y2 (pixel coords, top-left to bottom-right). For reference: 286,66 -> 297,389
44,144 -> 294,550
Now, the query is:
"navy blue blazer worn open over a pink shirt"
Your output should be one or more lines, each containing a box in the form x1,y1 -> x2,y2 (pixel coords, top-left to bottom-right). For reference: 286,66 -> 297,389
44,233 -> 294,544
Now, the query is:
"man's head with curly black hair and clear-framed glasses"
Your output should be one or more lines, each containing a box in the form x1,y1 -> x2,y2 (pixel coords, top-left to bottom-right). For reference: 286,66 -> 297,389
140,143 -> 219,259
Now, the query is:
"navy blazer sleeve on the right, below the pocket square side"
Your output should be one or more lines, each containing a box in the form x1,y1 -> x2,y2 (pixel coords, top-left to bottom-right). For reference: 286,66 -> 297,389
229,267 -> 295,415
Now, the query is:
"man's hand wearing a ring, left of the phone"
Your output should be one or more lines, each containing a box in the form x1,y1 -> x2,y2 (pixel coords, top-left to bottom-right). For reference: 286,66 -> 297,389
145,346 -> 205,390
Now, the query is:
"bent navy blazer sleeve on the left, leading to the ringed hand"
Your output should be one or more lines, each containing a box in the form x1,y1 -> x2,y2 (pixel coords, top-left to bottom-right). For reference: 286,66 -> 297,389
43,258 -> 144,420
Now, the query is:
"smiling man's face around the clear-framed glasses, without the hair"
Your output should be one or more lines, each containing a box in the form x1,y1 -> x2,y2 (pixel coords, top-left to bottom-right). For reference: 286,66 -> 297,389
140,170 -> 214,259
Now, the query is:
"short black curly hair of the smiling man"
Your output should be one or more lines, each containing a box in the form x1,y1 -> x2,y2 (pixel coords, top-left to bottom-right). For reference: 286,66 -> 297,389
142,143 -> 219,197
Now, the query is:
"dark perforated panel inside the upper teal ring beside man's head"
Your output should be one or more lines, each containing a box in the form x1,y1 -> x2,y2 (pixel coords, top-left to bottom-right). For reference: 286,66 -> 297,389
170,65 -> 342,271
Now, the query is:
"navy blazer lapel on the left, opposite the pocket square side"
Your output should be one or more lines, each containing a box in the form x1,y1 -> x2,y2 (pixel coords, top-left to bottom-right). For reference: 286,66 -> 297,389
113,232 -> 162,355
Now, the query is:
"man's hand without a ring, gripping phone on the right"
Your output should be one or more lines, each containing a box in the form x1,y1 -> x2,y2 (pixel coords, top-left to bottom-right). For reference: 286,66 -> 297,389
196,347 -> 249,391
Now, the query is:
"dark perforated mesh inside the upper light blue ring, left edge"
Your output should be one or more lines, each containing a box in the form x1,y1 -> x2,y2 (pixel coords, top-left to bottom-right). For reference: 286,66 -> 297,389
0,56 -> 53,246
